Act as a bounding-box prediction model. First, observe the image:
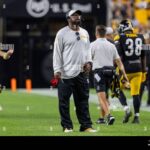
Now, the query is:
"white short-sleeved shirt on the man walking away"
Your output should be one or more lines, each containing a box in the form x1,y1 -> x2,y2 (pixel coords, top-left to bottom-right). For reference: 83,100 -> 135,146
90,38 -> 120,70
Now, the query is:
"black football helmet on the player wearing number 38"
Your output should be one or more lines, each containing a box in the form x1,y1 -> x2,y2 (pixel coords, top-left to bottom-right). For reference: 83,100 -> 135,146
118,19 -> 133,33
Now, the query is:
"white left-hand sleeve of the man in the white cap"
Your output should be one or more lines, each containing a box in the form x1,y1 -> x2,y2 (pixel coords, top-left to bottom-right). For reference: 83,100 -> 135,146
53,34 -> 63,73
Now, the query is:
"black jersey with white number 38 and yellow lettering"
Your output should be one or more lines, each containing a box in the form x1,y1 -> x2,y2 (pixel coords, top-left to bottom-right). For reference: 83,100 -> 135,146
114,33 -> 145,73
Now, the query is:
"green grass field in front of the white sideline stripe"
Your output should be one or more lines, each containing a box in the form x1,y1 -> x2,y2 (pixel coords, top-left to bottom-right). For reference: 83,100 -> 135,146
0,91 -> 150,136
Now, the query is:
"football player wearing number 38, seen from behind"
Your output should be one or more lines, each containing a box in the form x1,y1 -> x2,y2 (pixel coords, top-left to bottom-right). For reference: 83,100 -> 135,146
115,19 -> 146,123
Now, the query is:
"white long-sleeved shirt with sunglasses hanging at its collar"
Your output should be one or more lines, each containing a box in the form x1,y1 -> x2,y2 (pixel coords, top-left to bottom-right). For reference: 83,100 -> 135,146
53,26 -> 92,79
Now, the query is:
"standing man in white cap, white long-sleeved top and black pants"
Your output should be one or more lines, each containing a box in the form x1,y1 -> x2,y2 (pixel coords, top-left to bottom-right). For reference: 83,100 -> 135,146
53,10 -> 96,132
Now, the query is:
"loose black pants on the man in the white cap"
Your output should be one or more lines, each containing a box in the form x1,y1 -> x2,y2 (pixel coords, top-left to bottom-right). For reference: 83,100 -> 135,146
58,73 -> 92,130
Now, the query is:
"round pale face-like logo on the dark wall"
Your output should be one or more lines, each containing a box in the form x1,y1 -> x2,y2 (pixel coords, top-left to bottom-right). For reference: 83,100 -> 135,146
26,0 -> 50,18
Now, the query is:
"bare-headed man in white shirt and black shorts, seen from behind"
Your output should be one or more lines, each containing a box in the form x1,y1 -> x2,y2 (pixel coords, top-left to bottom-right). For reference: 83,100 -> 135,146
90,25 -> 128,125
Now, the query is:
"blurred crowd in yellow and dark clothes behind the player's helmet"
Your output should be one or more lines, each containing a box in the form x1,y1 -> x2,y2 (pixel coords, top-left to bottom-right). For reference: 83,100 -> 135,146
110,0 -> 150,43
